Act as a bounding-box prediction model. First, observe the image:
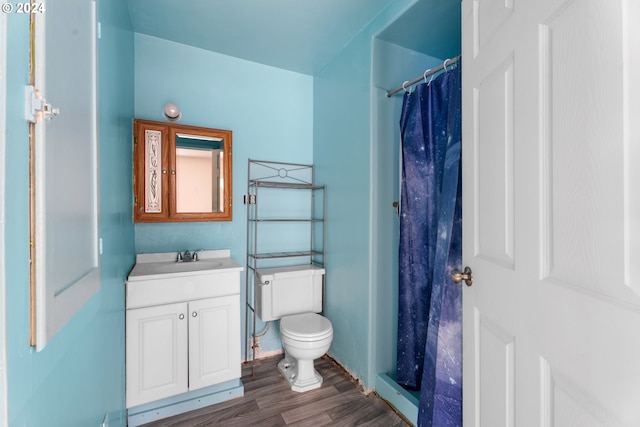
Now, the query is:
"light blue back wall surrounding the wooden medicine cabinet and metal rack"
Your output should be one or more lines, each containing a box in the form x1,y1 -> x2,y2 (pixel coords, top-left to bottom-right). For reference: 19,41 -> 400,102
135,34 -> 313,360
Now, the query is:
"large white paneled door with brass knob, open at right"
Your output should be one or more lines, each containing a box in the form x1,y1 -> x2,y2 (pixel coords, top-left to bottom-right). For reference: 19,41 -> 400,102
462,0 -> 640,427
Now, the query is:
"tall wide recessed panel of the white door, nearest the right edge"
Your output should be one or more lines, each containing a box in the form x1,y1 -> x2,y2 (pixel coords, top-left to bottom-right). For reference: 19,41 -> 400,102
540,0 -> 637,301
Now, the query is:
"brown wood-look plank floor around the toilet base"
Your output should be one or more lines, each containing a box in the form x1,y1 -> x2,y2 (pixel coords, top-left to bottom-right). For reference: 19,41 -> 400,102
144,356 -> 410,427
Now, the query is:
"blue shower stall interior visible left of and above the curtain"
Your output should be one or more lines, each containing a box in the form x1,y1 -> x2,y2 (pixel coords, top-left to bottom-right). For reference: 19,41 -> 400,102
372,1 -> 460,425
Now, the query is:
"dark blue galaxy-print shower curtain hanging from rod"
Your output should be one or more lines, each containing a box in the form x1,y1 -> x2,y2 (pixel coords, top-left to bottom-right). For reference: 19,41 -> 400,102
396,66 -> 462,427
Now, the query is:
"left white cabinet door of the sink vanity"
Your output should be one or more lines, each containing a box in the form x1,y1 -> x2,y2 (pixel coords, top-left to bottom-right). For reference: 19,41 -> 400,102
126,303 -> 189,408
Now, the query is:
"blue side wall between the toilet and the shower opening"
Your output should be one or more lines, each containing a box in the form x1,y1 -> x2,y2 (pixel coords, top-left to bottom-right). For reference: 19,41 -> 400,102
313,1 -> 412,389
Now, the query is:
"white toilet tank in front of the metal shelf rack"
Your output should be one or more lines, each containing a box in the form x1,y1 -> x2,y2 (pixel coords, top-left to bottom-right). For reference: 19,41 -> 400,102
254,264 -> 324,322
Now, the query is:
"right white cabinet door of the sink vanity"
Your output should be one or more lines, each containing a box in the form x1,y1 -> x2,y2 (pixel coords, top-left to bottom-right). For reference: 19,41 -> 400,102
189,295 -> 242,390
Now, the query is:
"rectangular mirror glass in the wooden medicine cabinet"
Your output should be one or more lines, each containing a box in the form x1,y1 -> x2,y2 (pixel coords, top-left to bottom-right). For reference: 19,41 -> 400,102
176,133 -> 224,213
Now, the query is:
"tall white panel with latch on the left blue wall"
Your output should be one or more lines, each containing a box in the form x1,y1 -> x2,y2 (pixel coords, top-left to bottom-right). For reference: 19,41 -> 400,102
33,0 -> 100,350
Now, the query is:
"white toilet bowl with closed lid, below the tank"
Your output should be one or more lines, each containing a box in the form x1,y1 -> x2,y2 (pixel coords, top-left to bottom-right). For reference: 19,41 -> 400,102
278,313 -> 333,392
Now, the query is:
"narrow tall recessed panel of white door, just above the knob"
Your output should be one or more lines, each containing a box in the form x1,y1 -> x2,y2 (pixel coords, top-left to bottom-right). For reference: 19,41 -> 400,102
474,56 -> 515,268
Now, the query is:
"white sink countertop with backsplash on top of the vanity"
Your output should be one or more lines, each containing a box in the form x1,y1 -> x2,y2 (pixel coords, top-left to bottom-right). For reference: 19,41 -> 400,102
128,250 -> 242,282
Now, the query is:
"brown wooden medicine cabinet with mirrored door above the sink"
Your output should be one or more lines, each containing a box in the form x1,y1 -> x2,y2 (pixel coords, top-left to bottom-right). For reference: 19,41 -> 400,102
134,119 -> 232,222
